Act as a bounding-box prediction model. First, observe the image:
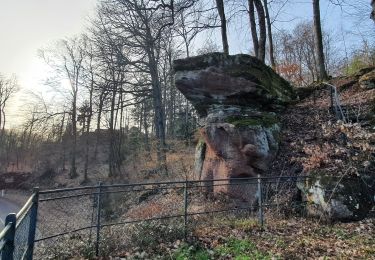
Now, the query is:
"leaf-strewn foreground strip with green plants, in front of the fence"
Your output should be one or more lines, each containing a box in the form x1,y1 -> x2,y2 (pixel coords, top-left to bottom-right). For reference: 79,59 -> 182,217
114,217 -> 375,260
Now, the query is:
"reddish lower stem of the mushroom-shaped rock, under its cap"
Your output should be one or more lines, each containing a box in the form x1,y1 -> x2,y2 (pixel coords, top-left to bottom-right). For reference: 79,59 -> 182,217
200,109 -> 280,179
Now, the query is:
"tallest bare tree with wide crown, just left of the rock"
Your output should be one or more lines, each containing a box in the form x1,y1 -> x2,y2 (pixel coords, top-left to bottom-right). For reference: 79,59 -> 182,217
94,0 -> 194,174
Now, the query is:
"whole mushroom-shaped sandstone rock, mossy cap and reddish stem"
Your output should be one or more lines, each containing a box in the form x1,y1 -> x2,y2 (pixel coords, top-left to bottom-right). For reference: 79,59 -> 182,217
174,53 -> 295,197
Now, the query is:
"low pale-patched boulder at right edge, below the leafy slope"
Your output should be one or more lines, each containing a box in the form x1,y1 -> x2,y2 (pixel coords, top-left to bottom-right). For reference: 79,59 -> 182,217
298,175 -> 375,221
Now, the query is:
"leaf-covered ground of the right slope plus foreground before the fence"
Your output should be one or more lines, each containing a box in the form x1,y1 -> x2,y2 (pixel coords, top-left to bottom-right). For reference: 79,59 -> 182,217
100,71 -> 375,260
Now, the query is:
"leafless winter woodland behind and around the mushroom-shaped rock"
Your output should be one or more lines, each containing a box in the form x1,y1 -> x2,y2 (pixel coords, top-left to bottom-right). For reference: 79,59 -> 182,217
0,0 -> 375,187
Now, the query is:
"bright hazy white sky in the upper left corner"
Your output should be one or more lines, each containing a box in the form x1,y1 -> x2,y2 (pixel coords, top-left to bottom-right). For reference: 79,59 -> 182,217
0,0 -> 96,127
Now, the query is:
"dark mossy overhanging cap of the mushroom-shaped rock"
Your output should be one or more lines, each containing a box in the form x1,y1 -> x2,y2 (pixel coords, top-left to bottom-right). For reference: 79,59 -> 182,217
174,53 -> 297,117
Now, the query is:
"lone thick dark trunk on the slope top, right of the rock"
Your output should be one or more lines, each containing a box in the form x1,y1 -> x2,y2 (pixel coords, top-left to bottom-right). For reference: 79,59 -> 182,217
313,0 -> 328,80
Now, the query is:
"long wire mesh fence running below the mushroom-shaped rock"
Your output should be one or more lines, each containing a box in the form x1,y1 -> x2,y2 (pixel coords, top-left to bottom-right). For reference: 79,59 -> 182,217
34,177 -> 303,259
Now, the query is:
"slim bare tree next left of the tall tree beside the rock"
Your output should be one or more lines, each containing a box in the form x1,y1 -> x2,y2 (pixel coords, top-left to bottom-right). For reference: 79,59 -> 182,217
93,23 -> 128,177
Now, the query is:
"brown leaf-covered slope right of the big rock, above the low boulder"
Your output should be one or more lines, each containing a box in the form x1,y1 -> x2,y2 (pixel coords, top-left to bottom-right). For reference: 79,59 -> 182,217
270,70 -> 375,176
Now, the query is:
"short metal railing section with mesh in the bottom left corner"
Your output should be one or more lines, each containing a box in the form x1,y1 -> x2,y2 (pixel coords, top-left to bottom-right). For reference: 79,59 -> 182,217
0,188 -> 39,260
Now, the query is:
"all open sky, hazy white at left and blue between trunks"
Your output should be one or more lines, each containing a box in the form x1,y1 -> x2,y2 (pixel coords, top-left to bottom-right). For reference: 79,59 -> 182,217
0,0 -> 370,127
